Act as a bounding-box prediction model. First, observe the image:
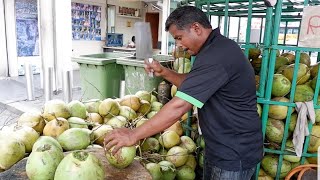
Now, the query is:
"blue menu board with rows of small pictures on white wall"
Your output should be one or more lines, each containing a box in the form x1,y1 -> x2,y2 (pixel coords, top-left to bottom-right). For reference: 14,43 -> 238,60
71,3 -> 101,41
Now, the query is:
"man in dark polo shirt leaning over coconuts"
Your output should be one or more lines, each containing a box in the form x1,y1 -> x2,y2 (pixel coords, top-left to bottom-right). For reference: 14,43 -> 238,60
105,6 -> 263,180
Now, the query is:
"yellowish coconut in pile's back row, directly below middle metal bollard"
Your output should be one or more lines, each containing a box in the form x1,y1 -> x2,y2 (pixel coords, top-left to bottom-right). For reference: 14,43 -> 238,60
42,100 -> 71,121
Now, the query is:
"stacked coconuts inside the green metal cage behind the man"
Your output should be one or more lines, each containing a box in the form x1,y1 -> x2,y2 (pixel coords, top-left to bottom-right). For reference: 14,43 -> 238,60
249,48 -> 320,179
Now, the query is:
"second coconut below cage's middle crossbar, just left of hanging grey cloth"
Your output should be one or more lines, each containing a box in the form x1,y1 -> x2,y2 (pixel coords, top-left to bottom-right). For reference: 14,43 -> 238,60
266,118 -> 284,143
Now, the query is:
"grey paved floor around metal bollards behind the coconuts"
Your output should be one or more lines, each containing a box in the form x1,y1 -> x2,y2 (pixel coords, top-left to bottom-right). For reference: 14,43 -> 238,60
0,71 -> 82,128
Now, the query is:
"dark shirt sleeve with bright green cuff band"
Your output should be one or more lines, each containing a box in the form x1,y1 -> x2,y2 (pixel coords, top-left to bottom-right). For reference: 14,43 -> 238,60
175,64 -> 228,108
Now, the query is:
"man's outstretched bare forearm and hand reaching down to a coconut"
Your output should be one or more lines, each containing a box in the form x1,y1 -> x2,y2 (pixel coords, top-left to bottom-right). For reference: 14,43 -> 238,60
105,97 -> 192,153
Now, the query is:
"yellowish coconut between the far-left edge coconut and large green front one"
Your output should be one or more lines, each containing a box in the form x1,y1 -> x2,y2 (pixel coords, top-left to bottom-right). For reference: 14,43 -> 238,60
15,126 -> 40,153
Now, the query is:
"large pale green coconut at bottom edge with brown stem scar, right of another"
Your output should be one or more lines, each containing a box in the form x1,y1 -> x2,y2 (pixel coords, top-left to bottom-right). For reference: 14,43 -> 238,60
54,151 -> 105,180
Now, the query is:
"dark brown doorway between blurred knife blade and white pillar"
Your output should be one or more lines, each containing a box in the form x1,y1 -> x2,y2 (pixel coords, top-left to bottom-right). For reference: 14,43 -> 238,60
146,13 -> 159,49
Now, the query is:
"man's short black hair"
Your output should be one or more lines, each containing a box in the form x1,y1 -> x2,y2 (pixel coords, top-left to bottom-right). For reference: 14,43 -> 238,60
165,6 -> 212,31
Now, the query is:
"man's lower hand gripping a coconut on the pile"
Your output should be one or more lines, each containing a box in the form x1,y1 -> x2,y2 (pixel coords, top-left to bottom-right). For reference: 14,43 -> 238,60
104,128 -> 138,154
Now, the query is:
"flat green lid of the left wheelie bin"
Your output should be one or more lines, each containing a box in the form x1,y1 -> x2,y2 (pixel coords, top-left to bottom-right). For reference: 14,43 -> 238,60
71,52 -> 132,66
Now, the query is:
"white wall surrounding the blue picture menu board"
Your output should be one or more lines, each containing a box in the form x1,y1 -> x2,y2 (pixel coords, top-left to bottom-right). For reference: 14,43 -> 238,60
70,0 -> 107,56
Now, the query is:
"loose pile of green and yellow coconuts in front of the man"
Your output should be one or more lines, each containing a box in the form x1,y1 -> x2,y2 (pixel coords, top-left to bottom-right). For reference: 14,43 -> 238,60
0,91 -> 202,180
